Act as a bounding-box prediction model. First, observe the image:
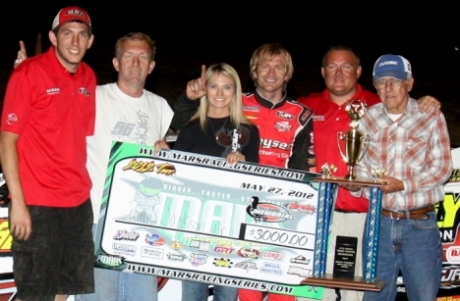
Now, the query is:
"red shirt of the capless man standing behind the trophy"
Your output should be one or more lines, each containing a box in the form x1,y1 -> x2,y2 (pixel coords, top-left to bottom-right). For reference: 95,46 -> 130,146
297,85 -> 380,212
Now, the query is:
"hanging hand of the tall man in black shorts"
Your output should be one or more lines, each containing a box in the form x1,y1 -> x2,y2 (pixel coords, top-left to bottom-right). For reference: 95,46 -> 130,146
10,200 -> 32,240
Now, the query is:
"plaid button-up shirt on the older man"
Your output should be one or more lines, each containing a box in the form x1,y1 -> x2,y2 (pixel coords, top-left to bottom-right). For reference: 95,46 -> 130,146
358,98 -> 452,210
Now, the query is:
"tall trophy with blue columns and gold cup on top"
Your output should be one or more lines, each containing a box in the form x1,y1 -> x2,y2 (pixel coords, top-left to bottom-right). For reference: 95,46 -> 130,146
308,100 -> 386,291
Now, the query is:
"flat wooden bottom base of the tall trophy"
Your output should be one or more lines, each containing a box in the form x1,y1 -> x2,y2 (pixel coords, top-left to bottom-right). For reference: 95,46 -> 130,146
300,274 -> 385,292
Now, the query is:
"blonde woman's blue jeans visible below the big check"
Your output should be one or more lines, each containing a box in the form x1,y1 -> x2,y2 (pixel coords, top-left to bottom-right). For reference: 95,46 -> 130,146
182,280 -> 238,301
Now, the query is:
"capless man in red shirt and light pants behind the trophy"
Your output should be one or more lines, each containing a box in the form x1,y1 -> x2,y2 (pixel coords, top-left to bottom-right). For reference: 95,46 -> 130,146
297,46 -> 440,301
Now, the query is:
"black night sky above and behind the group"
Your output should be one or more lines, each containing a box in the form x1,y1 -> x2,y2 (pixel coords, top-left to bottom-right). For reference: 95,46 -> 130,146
0,1 -> 460,145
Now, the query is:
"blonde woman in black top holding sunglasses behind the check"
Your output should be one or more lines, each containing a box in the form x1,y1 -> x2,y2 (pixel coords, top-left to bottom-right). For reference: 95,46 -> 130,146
174,63 -> 260,301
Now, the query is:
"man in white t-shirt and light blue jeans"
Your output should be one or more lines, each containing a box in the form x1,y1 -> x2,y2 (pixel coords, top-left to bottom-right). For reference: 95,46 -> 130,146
80,32 -> 173,301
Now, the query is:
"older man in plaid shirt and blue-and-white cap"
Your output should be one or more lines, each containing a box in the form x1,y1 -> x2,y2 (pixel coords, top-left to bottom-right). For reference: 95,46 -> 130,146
349,55 -> 452,300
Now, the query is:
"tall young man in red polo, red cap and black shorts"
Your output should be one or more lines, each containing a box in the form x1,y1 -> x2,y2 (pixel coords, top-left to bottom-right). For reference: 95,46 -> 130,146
1,7 -> 96,301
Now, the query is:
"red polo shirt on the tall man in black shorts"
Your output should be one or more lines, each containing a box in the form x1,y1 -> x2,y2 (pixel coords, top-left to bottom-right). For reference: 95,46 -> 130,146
1,47 -> 96,207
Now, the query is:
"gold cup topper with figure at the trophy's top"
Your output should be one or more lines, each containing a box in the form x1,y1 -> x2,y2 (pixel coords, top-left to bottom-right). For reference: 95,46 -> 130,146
337,100 -> 370,181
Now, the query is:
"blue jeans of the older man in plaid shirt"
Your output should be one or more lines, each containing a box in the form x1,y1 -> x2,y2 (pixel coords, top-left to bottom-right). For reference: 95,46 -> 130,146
363,212 -> 442,301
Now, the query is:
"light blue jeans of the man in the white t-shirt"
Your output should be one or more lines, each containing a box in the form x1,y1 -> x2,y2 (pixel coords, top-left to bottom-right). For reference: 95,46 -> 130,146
75,225 -> 158,301
